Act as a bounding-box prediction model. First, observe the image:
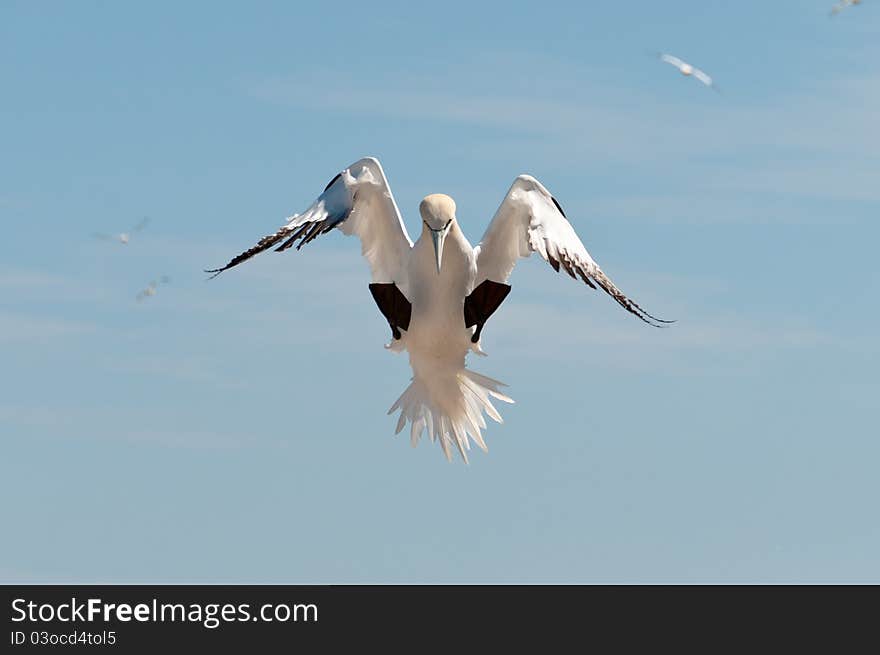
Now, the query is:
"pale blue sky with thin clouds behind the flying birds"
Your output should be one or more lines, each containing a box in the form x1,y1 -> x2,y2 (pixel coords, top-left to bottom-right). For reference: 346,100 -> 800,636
0,0 -> 880,583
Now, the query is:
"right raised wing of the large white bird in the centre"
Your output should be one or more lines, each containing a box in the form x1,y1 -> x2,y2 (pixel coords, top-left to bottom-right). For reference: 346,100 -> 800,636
474,175 -> 673,327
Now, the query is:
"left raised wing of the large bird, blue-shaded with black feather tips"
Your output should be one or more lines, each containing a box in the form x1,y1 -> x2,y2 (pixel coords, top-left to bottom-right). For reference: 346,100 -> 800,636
205,157 -> 412,283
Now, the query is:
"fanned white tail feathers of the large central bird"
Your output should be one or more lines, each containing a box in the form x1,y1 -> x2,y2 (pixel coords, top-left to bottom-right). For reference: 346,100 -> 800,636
388,368 -> 513,463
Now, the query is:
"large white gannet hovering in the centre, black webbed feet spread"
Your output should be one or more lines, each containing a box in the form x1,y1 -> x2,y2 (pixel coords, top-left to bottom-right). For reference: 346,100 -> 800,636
206,157 -> 672,462
